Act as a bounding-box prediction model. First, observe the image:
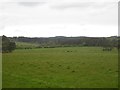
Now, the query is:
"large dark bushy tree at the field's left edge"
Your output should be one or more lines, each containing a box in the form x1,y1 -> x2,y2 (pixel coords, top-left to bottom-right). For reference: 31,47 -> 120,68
2,35 -> 16,53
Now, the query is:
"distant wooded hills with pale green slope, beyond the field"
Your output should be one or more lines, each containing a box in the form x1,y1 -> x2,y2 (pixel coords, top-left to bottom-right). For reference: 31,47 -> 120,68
9,36 -> 118,48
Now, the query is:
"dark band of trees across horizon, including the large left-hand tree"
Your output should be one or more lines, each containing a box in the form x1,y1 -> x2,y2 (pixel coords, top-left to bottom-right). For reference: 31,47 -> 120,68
0,35 -> 120,52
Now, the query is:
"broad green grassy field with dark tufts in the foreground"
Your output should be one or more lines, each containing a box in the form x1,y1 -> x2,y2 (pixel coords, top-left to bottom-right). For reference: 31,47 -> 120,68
3,47 -> 118,88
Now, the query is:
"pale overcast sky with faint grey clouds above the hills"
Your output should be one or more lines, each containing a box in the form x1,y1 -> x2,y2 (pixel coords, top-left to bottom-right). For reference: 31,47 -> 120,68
0,0 -> 118,37
